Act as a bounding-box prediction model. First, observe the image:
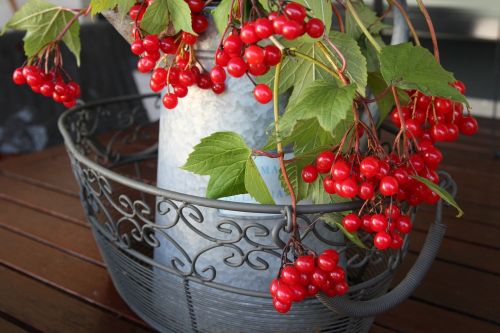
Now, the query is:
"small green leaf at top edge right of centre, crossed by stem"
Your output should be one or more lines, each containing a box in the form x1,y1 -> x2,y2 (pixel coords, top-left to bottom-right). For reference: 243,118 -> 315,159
346,0 -> 388,40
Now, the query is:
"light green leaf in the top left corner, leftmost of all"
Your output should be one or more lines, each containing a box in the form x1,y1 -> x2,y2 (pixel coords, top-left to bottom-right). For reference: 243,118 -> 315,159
2,0 -> 81,65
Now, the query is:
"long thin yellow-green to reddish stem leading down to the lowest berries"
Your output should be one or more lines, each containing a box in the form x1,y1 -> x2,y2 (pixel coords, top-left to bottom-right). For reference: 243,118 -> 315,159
273,54 -> 298,236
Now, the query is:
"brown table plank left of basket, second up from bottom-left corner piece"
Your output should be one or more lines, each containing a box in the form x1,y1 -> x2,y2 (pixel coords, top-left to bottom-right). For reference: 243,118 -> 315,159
0,228 -> 140,322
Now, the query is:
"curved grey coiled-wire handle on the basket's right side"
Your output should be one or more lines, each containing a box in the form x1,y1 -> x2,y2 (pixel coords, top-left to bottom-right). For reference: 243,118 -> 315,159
317,173 -> 456,317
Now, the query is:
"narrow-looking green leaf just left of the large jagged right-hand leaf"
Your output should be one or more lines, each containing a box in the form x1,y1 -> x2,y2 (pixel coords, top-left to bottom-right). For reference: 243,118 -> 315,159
330,31 -> 368,96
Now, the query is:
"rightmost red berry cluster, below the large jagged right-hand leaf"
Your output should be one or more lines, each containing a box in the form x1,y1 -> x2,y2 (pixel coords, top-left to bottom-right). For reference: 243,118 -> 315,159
390,81 -> 478,141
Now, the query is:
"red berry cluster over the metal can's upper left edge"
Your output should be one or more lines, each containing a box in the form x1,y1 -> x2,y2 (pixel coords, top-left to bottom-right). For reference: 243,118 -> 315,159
129,0 -> 217,109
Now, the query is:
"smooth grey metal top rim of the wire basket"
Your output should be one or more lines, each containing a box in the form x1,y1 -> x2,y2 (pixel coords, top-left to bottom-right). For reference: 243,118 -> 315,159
58,94 -> 363,214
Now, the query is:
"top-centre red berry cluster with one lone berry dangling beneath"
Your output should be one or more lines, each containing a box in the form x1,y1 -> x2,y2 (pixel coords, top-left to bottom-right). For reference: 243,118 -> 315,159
210,2 -> 325,104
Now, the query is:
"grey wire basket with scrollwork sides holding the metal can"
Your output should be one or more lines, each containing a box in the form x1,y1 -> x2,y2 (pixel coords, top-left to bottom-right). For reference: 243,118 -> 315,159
59,95 -> 452,332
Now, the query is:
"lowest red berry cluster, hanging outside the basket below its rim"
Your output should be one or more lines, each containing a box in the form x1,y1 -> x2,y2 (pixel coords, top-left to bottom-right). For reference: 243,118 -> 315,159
269,249 -> 349,313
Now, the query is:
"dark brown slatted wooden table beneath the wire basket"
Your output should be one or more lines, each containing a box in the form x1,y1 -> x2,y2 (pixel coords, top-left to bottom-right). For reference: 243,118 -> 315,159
0,118 -> 500,333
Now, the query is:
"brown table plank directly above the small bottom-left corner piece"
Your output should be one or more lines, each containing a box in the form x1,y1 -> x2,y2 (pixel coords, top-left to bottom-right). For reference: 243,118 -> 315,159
0,266 -> 151,333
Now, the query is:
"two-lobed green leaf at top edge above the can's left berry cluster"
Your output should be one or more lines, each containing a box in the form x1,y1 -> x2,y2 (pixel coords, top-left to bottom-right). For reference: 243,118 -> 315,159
141,0 -> 196,35
